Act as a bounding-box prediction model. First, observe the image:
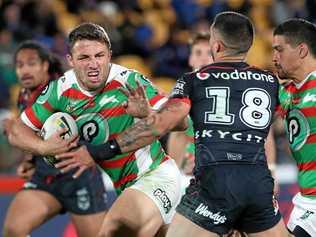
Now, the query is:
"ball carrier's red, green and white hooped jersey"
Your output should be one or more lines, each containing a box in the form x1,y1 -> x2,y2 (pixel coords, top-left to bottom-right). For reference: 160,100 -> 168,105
21,64 -> 168,193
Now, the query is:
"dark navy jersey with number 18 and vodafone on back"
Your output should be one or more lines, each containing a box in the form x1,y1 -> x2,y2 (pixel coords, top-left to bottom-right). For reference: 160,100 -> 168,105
170,62 -> 278,166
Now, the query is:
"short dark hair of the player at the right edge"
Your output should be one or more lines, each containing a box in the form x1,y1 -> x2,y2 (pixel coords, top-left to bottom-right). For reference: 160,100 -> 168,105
273,18 -> 316,56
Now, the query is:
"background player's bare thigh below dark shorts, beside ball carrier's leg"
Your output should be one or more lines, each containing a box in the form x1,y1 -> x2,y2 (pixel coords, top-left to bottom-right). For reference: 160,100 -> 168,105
70,211 -> 106,237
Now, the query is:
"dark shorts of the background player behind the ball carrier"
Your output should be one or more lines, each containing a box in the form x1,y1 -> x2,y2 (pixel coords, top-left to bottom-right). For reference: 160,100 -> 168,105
24,168 -> 107,215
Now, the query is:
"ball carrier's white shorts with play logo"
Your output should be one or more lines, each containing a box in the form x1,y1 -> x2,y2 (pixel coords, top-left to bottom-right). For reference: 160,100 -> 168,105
129,159 -> 182,224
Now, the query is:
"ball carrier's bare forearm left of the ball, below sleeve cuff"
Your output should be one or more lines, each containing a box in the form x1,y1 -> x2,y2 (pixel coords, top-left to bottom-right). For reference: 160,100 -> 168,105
8,119 -> 43,155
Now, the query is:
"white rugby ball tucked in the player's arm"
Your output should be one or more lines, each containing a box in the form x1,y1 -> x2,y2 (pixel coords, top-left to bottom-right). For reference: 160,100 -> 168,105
40,112 -> 78,166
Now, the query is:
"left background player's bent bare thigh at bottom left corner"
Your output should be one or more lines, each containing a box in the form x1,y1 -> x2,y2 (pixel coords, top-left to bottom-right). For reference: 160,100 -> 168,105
4,190 -> 62,231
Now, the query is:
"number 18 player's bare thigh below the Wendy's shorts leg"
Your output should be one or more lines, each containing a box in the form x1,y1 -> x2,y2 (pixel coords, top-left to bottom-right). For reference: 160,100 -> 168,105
166,213 -> 220,237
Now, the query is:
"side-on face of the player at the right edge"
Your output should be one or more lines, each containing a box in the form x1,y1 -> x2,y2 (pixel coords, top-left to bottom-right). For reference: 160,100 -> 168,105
272,35 -> 301,79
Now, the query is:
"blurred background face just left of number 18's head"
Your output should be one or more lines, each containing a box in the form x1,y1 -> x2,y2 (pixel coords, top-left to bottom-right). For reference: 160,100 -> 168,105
189,40 -> 213,70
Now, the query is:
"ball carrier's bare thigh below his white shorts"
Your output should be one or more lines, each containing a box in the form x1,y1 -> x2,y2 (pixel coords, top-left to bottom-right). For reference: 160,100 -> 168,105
99,188 -> 163,237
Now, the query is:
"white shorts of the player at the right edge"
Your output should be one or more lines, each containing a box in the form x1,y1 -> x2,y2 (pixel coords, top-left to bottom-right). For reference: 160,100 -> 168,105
287,193 -> 316,236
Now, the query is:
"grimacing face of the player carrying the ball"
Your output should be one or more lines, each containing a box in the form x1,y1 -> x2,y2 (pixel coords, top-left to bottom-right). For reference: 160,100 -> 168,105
67,39 -> 111,91
